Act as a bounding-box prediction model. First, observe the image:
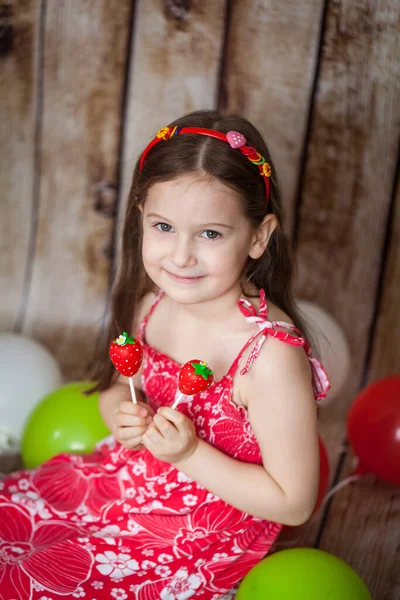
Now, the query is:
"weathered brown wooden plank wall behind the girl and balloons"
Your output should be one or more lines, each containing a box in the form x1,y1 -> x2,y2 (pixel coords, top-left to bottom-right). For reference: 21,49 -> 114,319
0,0 -> 400,600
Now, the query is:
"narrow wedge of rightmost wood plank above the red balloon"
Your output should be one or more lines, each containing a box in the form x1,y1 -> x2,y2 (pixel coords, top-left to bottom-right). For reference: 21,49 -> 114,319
368,172 -> 400,382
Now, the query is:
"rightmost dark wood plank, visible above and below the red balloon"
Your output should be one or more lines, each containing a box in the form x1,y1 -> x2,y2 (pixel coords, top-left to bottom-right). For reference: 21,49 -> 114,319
319,166 -> 400,600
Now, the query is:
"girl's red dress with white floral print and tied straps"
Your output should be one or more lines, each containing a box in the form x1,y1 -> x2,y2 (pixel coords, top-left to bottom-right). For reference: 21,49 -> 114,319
0,291 -> 329,600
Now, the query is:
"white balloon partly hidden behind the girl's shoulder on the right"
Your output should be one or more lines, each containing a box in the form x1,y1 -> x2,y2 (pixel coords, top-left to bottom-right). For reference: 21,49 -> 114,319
297,300 -> 351,404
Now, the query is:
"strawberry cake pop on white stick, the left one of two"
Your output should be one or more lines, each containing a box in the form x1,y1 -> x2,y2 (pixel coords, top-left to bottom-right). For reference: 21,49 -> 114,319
109,331 -> 143,404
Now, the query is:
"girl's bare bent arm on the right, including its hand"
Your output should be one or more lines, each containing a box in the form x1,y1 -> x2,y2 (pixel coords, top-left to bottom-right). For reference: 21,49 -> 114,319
143,338 -> 319,525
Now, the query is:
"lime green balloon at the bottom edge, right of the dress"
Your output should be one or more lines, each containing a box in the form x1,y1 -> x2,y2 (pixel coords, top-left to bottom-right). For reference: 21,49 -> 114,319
235,548 -> 371,600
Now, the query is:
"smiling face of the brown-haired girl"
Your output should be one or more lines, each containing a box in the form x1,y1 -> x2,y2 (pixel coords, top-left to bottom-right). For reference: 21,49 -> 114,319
142,173 -> 266,304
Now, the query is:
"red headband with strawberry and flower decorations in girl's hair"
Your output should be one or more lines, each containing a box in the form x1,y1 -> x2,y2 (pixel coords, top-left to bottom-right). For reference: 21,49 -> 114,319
139,126 -> 271,206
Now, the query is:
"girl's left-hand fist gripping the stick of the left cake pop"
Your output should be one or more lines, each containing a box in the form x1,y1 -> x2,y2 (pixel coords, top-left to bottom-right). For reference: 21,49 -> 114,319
114,400 -> 154,450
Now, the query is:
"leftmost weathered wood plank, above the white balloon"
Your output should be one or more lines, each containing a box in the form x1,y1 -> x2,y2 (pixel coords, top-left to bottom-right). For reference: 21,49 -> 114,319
0,0 -> 41,331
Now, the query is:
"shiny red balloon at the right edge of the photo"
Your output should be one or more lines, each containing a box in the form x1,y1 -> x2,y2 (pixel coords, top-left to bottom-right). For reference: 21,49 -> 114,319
347,375 -> 400,485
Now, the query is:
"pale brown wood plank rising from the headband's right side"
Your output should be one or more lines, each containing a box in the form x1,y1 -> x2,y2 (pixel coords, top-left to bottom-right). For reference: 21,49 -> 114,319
221,0 -> 324,234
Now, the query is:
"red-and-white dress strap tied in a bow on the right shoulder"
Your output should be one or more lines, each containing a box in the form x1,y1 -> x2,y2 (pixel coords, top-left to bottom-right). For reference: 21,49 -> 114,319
228,289 -> 330,402
